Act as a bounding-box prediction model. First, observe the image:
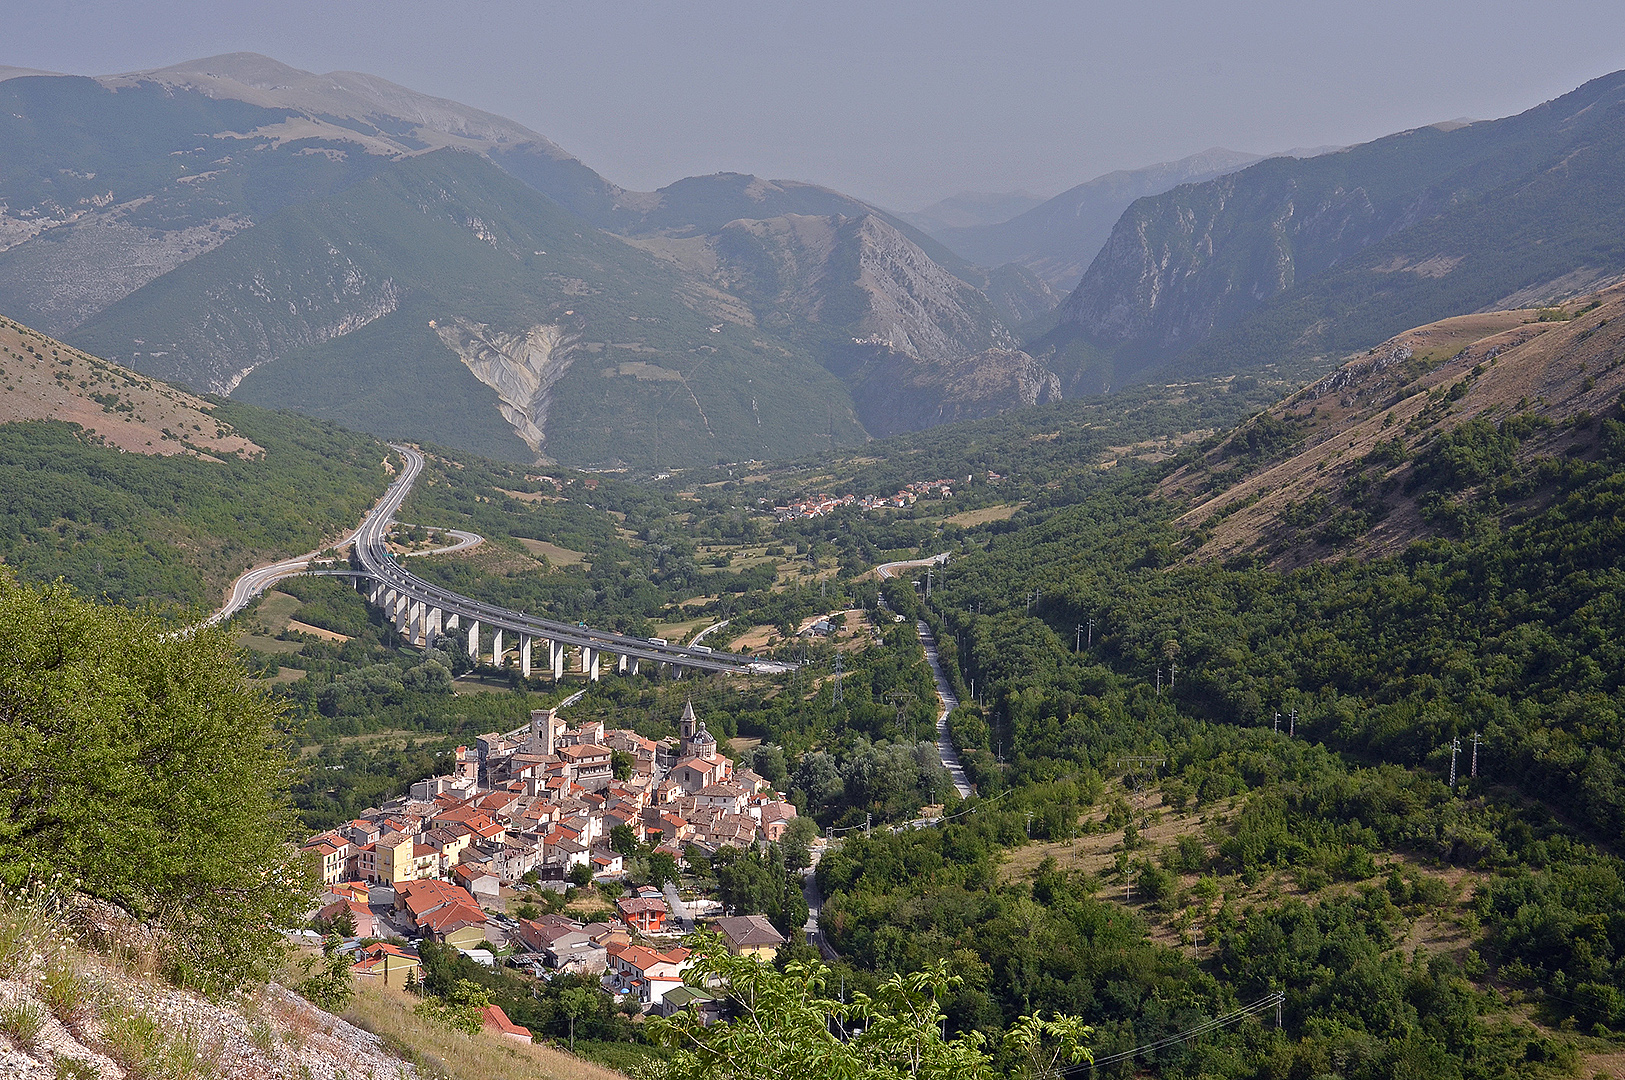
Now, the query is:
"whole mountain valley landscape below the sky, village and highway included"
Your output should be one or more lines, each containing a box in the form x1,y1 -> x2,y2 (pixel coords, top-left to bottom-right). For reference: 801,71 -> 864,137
0,42 -> 1625,1080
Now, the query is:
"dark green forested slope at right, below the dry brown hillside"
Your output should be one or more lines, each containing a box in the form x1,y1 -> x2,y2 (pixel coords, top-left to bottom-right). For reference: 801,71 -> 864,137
821,384 -> 1625,1077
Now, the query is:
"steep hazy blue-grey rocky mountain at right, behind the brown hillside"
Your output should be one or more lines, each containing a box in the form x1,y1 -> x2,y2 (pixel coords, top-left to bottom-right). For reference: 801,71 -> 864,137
1047,71 -> 1625,383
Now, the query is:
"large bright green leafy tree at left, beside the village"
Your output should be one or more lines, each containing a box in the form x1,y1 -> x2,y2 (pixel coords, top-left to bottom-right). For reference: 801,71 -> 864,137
0,568 -> 317,992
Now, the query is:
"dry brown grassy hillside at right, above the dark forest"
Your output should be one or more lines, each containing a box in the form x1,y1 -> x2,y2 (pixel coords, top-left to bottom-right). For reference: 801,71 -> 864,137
1160,286 -> 1625,567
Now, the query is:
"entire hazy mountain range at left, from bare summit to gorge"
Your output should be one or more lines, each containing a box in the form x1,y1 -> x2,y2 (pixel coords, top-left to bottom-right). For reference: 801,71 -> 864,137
0,54 -> 1060,466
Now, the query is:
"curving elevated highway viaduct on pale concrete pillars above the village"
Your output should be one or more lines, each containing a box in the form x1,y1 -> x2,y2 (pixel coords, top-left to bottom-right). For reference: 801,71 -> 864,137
353,443 -> 793,680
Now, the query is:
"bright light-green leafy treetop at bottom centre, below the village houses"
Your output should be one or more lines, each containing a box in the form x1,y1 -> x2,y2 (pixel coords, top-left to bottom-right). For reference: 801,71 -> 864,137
647,934 -> 1076,1080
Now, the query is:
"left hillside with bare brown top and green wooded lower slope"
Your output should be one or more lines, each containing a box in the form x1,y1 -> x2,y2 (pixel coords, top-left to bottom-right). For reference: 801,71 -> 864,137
0,322 -> 388,607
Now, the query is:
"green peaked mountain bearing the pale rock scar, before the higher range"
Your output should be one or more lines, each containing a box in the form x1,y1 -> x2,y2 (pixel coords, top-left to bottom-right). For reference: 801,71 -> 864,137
75,149 -> 861,463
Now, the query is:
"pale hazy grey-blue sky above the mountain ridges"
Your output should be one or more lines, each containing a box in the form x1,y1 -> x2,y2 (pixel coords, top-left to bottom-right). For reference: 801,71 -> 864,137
9,0 -> 1625,210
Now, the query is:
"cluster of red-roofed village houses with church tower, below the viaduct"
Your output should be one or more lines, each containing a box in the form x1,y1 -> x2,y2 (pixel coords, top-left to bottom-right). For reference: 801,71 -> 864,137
304,703 -> 796,1041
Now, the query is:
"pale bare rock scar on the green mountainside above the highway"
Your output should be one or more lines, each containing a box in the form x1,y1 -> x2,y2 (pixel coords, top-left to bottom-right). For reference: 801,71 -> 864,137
436,317 -> 579,455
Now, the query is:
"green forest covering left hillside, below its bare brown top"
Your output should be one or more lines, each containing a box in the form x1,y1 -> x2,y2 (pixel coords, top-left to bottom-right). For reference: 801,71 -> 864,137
0,403 -> 388,607
